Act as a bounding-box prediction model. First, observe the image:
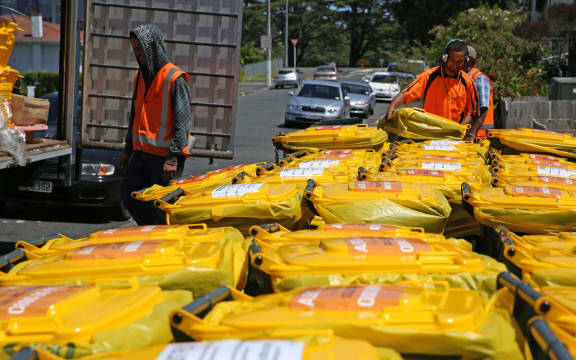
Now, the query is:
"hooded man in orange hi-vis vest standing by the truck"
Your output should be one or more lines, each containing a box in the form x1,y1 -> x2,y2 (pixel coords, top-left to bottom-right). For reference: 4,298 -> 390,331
118,24 -> 194,225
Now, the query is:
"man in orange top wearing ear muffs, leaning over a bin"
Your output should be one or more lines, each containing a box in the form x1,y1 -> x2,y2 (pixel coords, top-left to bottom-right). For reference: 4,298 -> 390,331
385,39 -> 478,140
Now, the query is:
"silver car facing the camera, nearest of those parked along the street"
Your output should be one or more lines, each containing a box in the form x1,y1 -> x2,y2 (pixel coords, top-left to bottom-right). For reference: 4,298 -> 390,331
284,80 -> 350,126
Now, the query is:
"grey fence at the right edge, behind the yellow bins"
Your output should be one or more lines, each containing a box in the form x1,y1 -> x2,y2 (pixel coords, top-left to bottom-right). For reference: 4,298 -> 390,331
500,96 -> 576,133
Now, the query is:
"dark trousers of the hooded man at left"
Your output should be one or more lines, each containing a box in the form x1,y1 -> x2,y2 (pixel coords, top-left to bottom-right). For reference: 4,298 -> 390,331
120,151 -> 184,225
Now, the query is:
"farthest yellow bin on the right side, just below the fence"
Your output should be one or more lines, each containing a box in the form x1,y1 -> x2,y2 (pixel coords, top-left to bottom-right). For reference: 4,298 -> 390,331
488,129 -> 576,161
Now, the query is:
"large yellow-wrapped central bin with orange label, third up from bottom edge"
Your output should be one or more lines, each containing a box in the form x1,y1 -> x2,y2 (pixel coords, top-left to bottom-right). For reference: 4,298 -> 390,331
249,233 -> 505,297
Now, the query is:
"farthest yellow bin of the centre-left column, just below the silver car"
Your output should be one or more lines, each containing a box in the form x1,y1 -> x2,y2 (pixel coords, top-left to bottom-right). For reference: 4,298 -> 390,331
272,124 -> 389,153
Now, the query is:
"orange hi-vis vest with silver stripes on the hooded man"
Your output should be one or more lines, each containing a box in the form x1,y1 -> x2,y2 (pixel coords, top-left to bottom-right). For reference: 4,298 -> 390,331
132,63 -> 188,156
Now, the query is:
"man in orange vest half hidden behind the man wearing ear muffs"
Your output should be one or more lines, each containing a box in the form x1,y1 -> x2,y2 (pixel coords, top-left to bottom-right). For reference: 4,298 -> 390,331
464,46 -> 494,138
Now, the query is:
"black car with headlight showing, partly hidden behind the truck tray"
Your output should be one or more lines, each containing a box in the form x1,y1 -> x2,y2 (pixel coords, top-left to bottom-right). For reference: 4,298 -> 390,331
0,92 -> 130,220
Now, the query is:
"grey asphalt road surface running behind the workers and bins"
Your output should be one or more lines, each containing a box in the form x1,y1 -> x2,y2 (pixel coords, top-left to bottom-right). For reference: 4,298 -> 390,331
0,69 -> 387,241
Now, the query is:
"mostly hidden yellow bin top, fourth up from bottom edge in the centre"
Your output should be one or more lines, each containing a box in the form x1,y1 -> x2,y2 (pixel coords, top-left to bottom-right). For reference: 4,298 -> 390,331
250,224 -> 472,251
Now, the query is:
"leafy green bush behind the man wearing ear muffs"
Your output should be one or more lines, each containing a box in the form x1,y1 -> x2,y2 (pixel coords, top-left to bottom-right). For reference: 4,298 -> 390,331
428,6 -> 548,99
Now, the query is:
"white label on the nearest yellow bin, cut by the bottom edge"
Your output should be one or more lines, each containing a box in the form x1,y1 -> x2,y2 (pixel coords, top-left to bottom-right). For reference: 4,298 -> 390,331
156,340 -> 305,360
